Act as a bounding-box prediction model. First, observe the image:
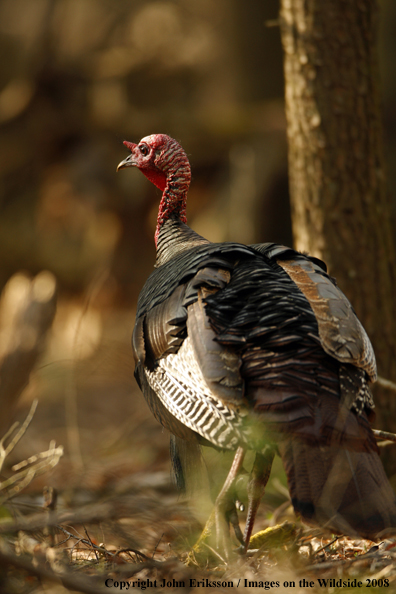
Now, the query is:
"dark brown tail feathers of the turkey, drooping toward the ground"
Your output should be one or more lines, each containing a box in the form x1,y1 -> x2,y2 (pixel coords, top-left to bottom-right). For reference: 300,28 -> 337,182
279,439 -> 396,538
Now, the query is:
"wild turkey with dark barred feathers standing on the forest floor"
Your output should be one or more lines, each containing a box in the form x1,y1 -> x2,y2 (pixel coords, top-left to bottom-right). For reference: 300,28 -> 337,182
117,134 -> 396,547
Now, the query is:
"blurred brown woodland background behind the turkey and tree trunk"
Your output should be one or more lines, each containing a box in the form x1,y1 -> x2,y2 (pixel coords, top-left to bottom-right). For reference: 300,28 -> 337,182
0,0 -> 396,532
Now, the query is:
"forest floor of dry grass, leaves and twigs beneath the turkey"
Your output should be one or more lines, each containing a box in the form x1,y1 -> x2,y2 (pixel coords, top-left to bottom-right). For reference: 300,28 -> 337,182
0,307 -> 396,594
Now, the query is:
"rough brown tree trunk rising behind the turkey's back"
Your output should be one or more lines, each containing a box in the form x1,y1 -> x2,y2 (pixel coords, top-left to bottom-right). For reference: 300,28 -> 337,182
281,0 -> 396,472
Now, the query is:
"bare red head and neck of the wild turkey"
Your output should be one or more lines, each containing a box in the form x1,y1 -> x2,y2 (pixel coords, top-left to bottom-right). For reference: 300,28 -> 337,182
117,134 -> 191,243
